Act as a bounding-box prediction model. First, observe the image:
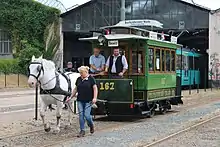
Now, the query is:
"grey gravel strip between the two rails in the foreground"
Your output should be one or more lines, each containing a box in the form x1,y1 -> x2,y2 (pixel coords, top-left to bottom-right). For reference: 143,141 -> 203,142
52,99 -> 220,147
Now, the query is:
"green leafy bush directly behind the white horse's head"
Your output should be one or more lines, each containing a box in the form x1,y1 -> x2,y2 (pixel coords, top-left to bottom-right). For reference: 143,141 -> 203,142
18,41 -> 42,74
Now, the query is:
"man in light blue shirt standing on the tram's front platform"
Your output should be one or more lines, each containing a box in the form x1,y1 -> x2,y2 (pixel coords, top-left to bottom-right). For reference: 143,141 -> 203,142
89,48 -> 105,74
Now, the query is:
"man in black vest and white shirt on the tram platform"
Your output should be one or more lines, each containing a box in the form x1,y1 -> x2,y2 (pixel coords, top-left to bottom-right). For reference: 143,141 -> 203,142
105,48 -> 128,78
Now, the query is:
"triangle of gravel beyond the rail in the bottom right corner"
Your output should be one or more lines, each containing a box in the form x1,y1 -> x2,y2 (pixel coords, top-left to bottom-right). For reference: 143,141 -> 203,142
152,118 -> 220,147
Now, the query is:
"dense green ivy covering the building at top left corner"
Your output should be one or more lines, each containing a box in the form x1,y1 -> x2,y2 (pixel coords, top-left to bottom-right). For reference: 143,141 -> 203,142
0,0 -> 60,52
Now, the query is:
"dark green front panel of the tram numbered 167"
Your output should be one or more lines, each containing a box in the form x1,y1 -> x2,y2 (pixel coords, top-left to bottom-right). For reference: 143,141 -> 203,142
92,79 -> 134,115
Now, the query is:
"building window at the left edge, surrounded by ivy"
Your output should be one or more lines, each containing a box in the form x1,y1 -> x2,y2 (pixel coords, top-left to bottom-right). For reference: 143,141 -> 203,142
0,29 -> 12,54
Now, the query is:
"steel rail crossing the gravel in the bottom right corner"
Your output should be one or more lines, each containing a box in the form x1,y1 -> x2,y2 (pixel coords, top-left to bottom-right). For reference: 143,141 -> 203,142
138,114 -> 220,147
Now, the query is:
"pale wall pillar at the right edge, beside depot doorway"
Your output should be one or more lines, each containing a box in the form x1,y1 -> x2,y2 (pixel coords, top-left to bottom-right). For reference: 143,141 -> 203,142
209,11 -> 220,80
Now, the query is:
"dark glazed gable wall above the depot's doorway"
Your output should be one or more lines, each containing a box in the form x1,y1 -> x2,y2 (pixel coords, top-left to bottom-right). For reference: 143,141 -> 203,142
63,0 -> 209,31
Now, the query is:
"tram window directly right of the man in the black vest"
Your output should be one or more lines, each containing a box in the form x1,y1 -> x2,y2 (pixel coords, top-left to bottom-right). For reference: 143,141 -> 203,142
132,51 -> 143,73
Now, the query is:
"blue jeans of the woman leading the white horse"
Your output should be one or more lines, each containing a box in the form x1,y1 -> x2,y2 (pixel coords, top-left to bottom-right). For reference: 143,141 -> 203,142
77,101 -> 93,131
